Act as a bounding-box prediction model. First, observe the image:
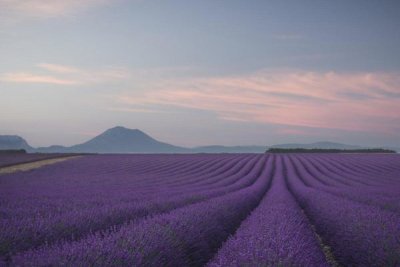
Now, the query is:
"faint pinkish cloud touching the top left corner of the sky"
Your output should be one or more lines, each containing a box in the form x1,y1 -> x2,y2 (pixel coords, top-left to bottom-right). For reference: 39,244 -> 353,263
0,0 -> 112,18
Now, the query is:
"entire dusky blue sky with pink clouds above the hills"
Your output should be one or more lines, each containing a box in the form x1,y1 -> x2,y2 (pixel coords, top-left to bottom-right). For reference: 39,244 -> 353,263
0,0 -> 400,147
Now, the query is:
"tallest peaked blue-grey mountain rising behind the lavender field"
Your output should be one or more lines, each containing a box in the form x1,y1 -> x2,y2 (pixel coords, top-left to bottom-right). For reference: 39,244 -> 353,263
66,126 -> 188,153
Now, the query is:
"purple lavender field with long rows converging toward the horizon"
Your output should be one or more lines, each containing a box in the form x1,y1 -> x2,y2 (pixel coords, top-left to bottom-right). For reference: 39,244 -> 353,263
0,154 -> 400,266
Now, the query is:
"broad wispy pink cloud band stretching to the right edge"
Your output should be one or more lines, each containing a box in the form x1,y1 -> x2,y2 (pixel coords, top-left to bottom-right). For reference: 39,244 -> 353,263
118,71 -> 400,133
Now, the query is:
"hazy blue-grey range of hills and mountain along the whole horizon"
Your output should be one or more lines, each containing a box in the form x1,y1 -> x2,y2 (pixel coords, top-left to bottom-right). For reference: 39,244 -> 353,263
0,129 -> 400,153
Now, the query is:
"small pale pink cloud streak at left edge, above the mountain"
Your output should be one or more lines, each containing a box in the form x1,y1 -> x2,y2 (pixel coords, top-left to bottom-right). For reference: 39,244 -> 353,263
0,63 -> 131,85
